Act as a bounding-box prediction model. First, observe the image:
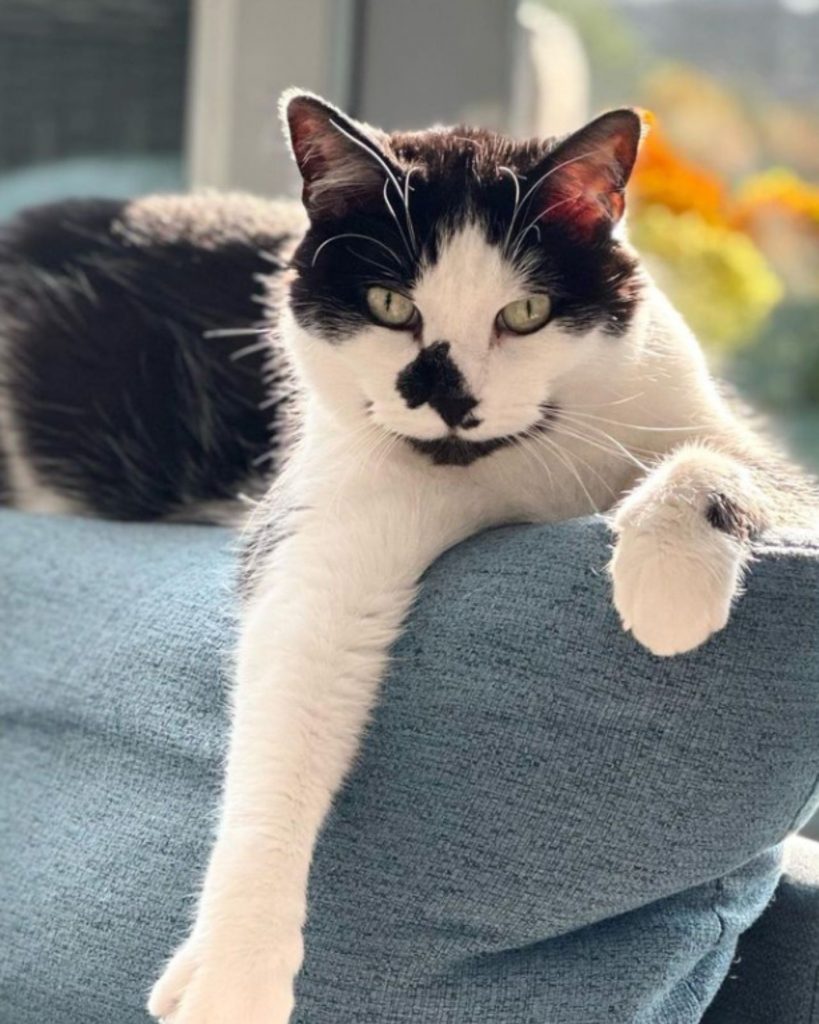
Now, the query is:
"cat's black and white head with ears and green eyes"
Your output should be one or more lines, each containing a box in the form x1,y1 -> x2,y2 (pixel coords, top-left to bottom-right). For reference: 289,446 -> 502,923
282,91 -> 642,464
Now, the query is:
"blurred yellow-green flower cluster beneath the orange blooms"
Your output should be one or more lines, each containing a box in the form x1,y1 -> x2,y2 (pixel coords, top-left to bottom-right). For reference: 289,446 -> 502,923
630,205 -> 783,350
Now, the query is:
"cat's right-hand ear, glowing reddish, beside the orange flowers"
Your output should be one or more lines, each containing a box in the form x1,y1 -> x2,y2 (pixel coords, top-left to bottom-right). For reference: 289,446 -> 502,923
535,109 -> 644,232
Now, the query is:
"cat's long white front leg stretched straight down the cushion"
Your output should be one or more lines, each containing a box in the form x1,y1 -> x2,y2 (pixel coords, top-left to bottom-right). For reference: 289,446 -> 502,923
148,481 -> 479,1024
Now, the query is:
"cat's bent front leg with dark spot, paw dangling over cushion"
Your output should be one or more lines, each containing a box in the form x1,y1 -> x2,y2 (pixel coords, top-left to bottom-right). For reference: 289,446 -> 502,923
609,444 -> 766,656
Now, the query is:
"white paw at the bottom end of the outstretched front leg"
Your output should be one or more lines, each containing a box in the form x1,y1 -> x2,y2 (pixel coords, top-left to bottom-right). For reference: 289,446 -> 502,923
147,938 -> 301,1024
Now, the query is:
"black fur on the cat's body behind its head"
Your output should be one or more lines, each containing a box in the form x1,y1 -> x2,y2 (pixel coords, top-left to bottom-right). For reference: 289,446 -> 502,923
0,199 -> 296,519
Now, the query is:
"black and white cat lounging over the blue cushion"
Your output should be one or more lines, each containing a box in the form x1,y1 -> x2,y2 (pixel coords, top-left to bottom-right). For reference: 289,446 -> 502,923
0,92 -> 816,1024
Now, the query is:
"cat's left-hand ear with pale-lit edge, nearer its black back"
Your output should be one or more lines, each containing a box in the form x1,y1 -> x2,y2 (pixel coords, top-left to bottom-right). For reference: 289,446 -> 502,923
279,89 -> 401,219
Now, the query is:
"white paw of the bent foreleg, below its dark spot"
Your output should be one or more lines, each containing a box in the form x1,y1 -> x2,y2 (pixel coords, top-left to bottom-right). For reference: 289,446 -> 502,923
609,510 -> 742,657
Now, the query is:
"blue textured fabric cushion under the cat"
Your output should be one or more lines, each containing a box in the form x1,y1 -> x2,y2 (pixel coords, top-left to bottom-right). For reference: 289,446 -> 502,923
0,512 -> 819,1024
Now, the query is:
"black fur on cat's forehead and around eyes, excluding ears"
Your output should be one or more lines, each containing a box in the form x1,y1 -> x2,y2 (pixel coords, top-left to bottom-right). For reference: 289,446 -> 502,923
292,118 -> 640,341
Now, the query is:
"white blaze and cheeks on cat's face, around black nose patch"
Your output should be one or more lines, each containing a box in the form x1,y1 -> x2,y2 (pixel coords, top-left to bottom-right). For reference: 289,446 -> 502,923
294,223 -> 628,441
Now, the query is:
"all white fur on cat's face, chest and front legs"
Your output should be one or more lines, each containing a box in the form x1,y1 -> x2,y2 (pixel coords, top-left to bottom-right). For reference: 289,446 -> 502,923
149,227 -> 769,1024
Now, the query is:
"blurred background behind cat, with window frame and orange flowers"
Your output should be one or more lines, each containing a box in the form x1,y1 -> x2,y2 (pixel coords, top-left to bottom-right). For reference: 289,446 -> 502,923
0,0 -> 819,468
